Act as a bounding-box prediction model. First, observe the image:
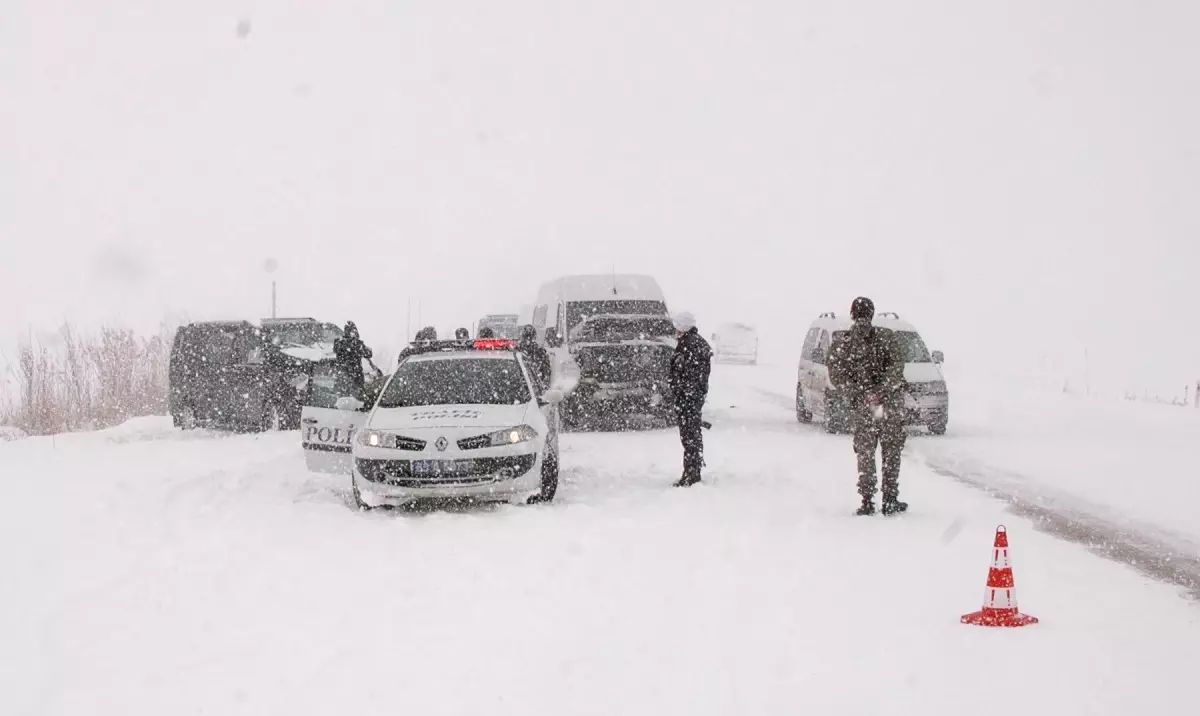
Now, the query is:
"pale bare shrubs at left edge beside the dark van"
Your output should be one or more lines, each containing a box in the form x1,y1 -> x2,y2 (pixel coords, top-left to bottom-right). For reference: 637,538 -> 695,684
0,324 -> 174,435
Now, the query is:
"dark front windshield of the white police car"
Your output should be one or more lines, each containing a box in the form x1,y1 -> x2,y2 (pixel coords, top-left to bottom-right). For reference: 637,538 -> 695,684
378,359 -> 533,408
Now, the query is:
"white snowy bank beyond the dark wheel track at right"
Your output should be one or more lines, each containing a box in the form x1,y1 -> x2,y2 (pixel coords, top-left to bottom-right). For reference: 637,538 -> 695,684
913,377 -> 1200,549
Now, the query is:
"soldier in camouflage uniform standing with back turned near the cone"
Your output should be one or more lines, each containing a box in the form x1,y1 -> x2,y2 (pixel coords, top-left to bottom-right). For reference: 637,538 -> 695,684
828,297 -> 908,515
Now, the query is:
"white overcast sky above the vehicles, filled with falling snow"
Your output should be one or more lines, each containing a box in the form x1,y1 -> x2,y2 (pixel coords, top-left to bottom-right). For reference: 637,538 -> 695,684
0,0 -> 1200,385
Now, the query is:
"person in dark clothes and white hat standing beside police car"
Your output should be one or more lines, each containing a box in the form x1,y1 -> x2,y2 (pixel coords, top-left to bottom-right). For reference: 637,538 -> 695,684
670,313 -> 713,487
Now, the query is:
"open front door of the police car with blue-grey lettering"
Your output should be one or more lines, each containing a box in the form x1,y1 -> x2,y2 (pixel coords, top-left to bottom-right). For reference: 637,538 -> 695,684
300,361 -> 371,475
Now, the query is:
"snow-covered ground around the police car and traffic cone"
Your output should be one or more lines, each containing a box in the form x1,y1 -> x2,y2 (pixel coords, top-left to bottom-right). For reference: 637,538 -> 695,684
0,366 -> 1200,715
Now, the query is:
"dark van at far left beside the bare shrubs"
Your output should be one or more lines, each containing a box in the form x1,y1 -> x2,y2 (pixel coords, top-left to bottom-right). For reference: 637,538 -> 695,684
169,321 -> 312,431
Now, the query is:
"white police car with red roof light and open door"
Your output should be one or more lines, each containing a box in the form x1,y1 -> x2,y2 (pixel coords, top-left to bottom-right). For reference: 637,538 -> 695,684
302,339 -> 563,509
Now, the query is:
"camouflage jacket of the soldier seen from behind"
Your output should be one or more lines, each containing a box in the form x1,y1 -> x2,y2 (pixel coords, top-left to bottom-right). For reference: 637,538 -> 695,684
827,324 -> 905,410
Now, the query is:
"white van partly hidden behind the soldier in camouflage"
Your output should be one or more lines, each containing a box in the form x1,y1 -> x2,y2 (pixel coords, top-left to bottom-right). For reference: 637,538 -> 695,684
796,313 -> 950,435
